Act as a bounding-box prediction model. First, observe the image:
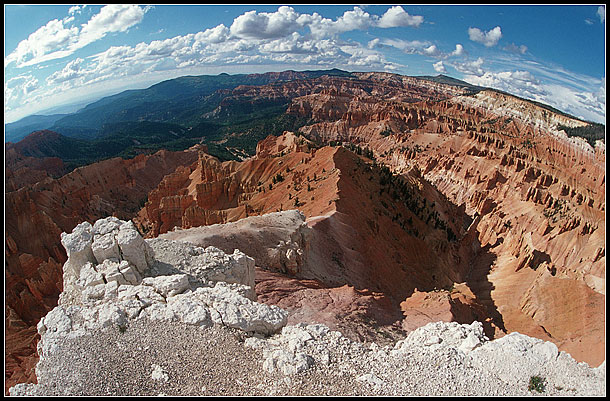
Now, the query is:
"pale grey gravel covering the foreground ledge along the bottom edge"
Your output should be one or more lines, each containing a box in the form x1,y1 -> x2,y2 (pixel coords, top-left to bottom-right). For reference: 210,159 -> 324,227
11,318 -> 605,396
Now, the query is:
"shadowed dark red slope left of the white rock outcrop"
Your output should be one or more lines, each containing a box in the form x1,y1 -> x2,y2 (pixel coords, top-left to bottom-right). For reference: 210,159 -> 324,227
5,145 -> 197,390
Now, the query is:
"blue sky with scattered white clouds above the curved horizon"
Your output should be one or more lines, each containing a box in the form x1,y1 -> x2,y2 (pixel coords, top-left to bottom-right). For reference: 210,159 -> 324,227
4,4 -> 606,124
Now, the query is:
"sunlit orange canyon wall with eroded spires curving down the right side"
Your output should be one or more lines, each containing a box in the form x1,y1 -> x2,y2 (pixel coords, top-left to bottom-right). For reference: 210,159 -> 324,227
288,76 -> 605,364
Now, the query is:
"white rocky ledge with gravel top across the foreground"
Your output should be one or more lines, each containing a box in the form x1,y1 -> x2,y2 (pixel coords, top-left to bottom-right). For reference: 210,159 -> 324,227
10,217 -> 606,396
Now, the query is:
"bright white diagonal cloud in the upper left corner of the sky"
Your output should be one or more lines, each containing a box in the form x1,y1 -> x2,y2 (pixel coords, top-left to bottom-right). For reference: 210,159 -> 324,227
4,4 -> 148,67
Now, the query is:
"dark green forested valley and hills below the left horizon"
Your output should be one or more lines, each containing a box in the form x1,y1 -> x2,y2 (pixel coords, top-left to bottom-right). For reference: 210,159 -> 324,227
19,98 -> 308,169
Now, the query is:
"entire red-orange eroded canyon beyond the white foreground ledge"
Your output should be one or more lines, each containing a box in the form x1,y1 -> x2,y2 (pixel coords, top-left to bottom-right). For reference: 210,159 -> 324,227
5,73 -> 605,388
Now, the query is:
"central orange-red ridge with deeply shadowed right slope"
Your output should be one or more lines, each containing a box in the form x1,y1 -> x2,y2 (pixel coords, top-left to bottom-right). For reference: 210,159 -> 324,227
138,133 -> 483,346
